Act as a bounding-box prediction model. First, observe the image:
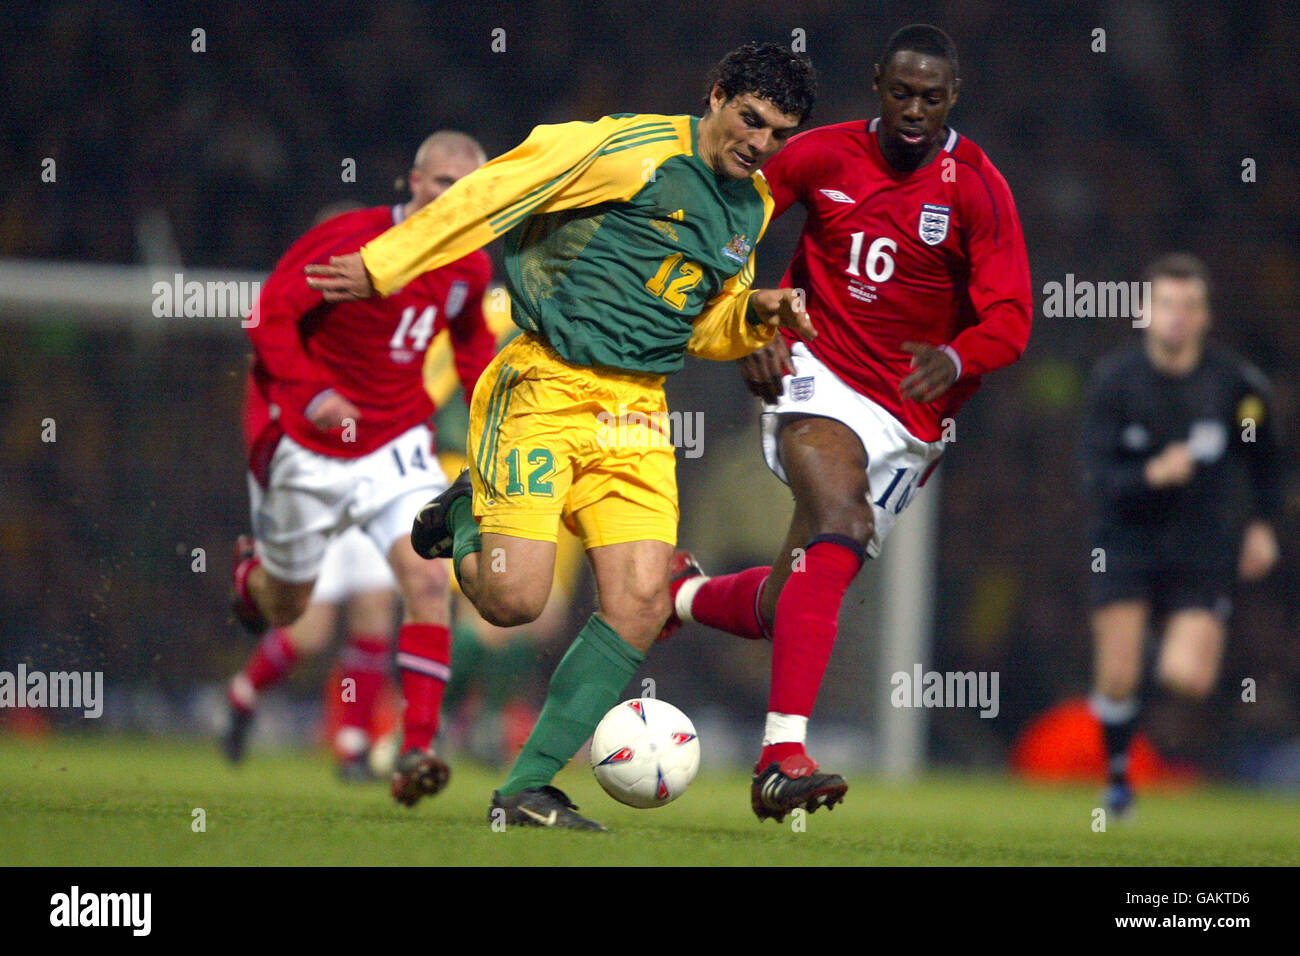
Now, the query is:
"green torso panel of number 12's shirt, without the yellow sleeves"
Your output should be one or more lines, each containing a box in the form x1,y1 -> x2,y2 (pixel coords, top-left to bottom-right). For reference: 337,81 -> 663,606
506,117 -> 767,375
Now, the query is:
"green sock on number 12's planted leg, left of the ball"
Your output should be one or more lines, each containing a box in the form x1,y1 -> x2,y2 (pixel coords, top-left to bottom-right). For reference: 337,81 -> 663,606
501,614 -> 645,796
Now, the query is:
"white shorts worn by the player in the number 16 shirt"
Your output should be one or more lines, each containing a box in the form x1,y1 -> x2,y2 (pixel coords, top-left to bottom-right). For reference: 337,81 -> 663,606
762,342 -> 945,558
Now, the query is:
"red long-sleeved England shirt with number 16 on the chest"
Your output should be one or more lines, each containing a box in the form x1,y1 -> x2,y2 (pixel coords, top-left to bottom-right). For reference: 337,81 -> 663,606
763,120 -> 1034,441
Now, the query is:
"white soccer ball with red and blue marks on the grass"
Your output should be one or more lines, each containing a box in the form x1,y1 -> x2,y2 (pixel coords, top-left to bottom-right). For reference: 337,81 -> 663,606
592,697 -> 699,810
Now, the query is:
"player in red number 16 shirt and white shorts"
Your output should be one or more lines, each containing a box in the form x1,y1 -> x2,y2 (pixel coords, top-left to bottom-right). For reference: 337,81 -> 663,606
670,25 -> 1032,819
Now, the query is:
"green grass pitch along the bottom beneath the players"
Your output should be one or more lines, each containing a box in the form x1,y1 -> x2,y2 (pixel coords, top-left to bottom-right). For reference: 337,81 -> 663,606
0,737 -> 1300,866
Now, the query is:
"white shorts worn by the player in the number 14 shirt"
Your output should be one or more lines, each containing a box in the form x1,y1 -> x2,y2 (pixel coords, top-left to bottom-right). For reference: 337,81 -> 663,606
248,425 -> 447,584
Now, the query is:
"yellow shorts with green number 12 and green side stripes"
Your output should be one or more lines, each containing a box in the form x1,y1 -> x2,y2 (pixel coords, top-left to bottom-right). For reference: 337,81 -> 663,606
468,334 -> 679,549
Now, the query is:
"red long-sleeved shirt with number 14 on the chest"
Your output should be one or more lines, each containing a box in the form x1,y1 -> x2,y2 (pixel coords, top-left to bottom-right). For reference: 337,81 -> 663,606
244,206 -> 495,475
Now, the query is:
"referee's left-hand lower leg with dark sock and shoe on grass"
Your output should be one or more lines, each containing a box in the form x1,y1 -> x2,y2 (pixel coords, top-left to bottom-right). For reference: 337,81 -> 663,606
1088,600 -> 1151,816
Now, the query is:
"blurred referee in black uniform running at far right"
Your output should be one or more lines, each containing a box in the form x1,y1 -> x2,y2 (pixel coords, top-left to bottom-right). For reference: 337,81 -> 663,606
1083,252 -> 1281,816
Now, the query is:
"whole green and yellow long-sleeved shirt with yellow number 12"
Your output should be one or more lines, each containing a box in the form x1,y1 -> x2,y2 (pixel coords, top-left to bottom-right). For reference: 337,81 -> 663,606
361,114 -> 772,375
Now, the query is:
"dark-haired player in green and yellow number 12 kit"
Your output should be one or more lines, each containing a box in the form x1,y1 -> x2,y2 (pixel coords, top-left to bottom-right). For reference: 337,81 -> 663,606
307,43 -> 815,830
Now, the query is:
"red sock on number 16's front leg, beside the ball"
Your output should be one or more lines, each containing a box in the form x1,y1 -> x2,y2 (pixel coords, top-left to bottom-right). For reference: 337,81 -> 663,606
759,535 -> 863,766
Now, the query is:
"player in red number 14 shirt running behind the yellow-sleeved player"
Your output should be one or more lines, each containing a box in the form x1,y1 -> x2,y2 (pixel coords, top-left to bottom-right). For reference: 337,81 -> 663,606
228,131 -> 495,805
